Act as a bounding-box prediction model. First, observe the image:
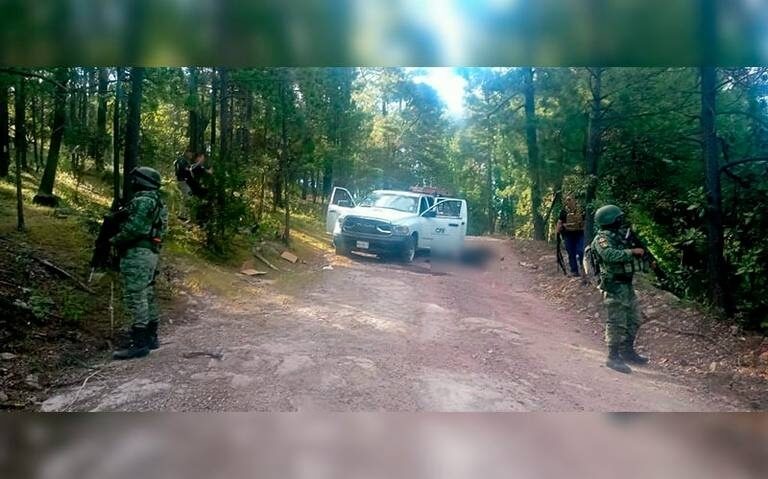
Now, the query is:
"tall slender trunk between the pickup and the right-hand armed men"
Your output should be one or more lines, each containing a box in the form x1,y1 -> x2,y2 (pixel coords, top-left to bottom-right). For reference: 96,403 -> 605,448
523,67 -> 545,240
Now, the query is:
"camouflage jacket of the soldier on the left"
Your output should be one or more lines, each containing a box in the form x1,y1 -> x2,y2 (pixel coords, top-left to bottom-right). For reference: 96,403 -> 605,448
110,191 -> 168,249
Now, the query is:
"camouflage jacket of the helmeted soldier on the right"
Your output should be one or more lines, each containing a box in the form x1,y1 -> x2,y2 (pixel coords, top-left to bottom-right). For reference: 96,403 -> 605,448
592,230 -> 643,284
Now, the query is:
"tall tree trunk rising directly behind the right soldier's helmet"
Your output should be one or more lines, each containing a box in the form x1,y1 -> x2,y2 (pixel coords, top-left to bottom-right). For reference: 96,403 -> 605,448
584,68 -> 603,244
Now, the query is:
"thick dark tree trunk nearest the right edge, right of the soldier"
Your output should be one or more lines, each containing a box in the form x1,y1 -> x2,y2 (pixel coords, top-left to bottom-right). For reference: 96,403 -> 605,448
699,66 -> 731,313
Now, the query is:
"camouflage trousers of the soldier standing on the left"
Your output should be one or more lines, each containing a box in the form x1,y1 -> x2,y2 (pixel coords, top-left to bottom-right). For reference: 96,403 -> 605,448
120,248 -> 159,328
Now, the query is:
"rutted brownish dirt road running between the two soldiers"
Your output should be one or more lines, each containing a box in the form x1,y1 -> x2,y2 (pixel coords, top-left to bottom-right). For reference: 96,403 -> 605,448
42,239 -> 743,411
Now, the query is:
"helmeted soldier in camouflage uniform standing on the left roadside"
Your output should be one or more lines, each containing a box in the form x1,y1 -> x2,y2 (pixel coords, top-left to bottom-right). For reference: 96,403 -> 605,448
110,167 -> 168,359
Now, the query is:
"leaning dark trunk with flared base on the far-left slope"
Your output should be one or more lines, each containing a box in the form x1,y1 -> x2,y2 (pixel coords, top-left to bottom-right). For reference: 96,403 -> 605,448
33,68 -> 69,206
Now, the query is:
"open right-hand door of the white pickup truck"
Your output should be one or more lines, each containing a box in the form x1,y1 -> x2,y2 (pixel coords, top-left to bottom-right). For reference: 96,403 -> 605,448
422,198 -> 467,255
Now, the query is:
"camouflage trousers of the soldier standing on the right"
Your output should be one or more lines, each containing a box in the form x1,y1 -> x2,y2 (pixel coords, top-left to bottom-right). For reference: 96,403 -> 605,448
601,281 -> 640,346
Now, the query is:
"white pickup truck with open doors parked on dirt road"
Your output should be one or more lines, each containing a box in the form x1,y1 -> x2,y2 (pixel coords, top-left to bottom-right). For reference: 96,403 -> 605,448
325,187 -> 467,263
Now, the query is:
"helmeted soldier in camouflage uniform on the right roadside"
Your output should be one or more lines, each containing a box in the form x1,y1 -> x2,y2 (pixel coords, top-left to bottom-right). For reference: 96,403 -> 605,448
592,205 -> 648,373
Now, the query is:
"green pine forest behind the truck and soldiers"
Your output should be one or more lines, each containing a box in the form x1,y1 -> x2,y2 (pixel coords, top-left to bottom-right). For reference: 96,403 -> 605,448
0,67 -> 768,330
